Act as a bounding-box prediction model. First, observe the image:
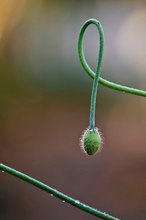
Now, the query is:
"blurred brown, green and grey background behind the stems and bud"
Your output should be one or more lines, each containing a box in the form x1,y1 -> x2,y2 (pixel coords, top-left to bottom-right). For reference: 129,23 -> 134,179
0,0 -> 146,220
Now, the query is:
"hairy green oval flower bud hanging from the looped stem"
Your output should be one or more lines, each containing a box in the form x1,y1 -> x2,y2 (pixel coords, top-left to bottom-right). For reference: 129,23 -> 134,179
81,128 -> 102,155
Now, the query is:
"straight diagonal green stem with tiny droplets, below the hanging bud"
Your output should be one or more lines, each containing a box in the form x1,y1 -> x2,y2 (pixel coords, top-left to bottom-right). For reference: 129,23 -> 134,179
0,164 -> 118,220
